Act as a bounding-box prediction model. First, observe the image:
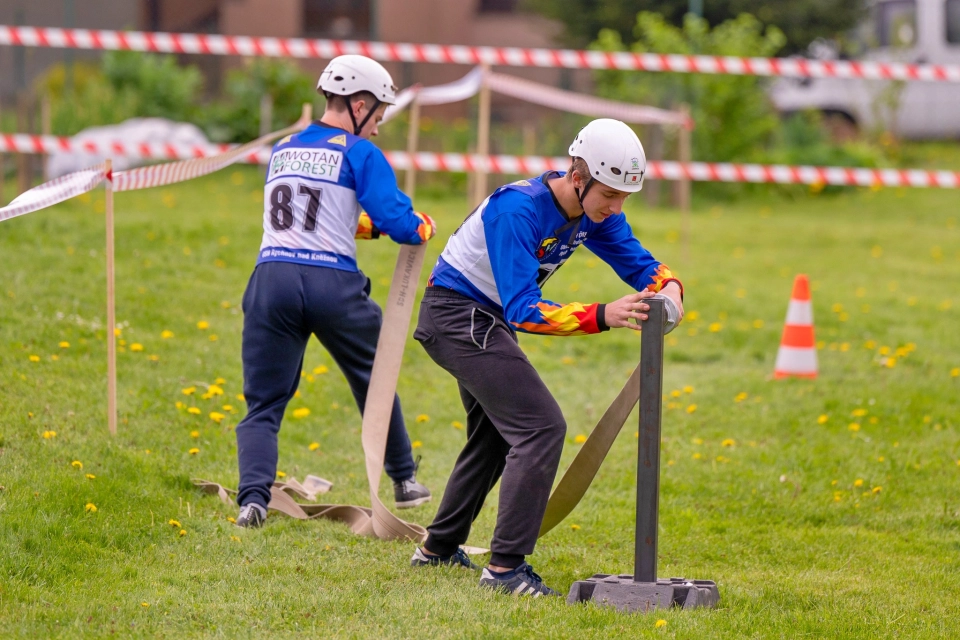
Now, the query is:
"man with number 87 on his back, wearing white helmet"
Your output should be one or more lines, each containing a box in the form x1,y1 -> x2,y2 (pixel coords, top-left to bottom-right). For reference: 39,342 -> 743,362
237,55 -> 435,527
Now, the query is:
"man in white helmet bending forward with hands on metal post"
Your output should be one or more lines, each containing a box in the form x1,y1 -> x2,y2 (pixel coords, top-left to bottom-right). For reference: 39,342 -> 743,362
411,120 -> 683,597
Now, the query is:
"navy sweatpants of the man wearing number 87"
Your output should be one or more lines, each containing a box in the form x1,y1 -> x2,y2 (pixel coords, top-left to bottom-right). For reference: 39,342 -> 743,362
237,262 -> 414,506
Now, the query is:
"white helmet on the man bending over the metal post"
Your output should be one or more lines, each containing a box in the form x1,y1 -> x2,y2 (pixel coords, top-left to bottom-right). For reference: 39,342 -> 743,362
569,118 -> 647,204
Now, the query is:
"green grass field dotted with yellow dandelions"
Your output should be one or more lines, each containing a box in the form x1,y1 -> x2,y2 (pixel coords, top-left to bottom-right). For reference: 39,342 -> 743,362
0,168 -> 960,638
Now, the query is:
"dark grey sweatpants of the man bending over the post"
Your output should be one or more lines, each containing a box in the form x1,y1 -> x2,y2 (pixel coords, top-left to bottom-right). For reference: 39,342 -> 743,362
413,287 -> 567,567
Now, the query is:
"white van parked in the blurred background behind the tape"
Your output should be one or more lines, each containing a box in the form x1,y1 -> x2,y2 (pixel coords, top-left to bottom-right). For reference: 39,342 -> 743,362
770,0 -> 960,139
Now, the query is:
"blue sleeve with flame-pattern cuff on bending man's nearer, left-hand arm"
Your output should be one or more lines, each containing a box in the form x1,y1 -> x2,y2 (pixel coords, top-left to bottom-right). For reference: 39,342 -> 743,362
483,198 -> 601,336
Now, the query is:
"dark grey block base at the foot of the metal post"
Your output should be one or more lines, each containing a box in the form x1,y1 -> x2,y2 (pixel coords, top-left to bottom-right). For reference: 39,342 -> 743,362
567,573 -> 720,613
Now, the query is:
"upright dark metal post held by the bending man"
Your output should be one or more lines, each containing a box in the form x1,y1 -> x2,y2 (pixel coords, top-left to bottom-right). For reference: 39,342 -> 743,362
633,299 -> 664,582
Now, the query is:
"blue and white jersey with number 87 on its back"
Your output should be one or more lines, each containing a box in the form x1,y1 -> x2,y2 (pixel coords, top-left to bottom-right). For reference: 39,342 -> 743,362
257,122 -> 423,271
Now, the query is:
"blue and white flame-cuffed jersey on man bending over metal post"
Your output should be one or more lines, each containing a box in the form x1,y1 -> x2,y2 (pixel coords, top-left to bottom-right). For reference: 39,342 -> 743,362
430,172 -> 682,335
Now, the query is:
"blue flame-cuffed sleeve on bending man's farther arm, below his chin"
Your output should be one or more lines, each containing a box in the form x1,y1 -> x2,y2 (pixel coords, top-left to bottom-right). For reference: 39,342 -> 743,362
584,213 -> 683,297
